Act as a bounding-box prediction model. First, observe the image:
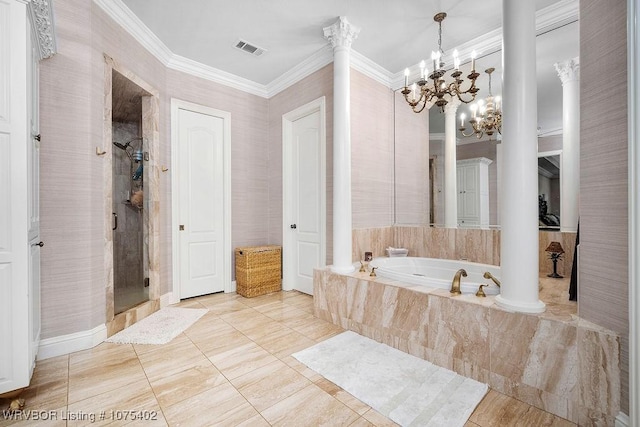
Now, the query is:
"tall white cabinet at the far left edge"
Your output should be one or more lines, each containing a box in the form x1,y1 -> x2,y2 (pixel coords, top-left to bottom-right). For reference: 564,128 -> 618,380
0,1 -> 40,393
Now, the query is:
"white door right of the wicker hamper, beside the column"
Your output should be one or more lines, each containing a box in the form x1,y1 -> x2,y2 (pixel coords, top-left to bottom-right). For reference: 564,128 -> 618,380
283,98 -> 326,294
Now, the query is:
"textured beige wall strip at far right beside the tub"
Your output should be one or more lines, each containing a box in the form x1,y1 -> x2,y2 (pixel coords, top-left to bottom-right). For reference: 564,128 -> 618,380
578,0 -> 637,413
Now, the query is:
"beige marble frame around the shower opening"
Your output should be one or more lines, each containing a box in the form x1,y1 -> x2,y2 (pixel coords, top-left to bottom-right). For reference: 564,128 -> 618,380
102,54 -> 160,336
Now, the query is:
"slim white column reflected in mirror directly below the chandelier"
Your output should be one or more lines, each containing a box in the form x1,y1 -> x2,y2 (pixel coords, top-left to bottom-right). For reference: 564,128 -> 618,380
444,98 -> 461,228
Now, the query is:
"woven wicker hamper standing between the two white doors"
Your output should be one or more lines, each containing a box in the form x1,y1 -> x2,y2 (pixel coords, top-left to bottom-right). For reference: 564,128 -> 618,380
236,245 -> 282,298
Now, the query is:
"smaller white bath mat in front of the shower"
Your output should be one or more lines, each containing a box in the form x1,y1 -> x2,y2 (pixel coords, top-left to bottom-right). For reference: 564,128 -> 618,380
106,307 -> 207,344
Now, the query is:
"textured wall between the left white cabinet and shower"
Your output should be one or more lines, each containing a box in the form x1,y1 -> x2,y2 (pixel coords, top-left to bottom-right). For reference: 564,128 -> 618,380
40,1 -> 112,338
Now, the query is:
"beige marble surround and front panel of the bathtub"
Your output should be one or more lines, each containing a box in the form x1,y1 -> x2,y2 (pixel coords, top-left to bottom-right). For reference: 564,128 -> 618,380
314,268 -> 620,425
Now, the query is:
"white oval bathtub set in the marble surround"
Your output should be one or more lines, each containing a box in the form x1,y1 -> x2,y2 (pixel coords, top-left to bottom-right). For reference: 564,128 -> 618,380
369,257 -> 500,295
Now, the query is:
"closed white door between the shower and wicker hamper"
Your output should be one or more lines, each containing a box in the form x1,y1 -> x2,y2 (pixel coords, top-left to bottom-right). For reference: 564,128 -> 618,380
174,109 -> 225,299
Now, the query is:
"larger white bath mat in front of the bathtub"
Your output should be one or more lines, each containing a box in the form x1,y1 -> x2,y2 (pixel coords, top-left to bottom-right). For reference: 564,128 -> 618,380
293,331 -> 489,427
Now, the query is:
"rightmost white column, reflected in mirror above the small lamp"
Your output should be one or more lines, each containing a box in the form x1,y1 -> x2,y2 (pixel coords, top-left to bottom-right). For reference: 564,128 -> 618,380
554,57 -> 580,232
